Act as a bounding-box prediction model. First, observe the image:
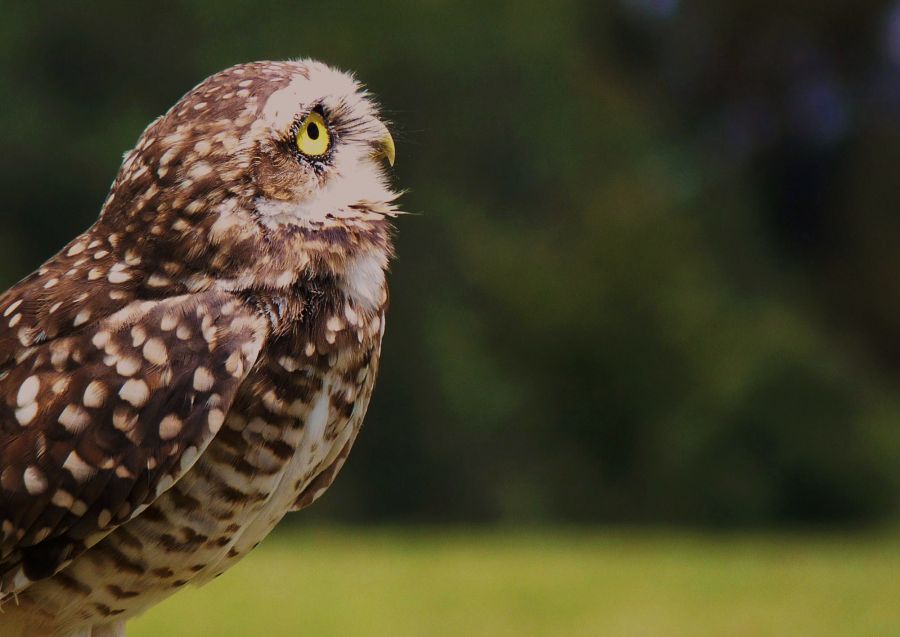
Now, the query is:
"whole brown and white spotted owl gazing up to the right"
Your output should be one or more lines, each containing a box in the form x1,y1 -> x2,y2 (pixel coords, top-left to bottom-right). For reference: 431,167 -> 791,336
0,60 -> 399,637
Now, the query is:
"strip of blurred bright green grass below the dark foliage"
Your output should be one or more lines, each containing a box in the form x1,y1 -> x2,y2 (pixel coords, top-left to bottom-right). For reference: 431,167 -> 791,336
129,528 -> 900,637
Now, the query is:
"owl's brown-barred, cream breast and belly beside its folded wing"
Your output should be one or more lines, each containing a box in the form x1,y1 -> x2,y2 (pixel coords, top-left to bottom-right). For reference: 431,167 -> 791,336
10,290 -> 386,624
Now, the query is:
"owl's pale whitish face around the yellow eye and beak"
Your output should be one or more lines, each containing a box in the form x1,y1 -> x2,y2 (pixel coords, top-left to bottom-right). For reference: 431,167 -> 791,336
253,64 -> 394,226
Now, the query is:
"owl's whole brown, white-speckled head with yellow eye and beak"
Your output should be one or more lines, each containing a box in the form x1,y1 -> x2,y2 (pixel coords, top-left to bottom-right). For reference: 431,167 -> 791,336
99,60 -> 397,288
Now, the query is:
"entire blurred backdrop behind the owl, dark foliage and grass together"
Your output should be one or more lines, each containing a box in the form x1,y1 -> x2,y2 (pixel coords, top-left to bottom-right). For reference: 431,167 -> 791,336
0,0 -> 900,635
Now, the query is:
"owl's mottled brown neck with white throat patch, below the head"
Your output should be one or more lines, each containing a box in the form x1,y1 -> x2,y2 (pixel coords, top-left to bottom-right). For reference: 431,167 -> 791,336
89,198 -> 393,311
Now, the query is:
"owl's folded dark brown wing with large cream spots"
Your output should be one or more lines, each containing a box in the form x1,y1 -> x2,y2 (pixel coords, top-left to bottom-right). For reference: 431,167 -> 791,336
0,291 -> 268,596
